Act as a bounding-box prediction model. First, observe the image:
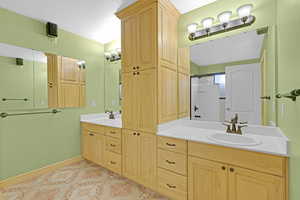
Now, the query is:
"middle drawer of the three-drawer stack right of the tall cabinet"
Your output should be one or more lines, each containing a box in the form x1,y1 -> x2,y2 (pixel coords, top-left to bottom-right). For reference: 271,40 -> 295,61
158,149 -> 187,175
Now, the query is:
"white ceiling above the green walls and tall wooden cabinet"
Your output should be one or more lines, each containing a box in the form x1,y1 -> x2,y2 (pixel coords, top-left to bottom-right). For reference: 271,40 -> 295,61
0,0 -> 216,44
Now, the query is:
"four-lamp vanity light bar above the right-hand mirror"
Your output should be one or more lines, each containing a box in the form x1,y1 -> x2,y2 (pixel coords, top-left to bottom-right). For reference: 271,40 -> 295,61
187,4 -> 256,41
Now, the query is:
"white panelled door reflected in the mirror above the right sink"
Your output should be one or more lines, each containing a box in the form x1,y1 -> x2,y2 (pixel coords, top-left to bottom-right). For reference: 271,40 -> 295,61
225,63 -> 261,124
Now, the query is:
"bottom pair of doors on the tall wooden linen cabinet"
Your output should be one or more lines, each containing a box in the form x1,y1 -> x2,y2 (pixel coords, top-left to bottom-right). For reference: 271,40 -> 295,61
122,129 -> 156,189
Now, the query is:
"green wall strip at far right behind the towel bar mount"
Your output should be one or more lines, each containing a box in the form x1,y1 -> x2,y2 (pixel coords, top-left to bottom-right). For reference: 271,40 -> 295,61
277,0 -> 300,200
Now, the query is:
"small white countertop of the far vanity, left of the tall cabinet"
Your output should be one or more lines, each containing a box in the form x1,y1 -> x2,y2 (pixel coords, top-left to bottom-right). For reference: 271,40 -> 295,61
80,113 -> 122,128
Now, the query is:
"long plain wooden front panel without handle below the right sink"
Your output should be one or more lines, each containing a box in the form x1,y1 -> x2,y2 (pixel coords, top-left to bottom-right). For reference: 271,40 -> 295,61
188,142 -> 287,176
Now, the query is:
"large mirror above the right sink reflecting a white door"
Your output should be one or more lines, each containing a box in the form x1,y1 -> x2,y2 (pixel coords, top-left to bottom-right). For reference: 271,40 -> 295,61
190,30 -> 276,125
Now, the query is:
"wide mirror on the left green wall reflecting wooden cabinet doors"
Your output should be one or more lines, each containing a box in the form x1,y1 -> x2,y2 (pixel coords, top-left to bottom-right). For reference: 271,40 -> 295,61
0,43 -> 87,112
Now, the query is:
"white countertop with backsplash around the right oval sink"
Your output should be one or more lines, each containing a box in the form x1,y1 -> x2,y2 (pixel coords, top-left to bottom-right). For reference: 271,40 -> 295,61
157,119 -> 288,157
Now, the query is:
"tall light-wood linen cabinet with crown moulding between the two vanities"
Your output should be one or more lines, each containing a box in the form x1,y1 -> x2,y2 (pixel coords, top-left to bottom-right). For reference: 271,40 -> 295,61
116,0 -> 180,189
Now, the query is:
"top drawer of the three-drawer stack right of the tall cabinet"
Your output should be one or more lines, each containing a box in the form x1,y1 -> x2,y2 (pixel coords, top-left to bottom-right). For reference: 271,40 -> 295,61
158,136 -> 187,154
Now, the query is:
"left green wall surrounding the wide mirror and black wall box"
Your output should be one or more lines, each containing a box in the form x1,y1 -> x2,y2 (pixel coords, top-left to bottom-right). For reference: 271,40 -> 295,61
0,9 -> 104,179
